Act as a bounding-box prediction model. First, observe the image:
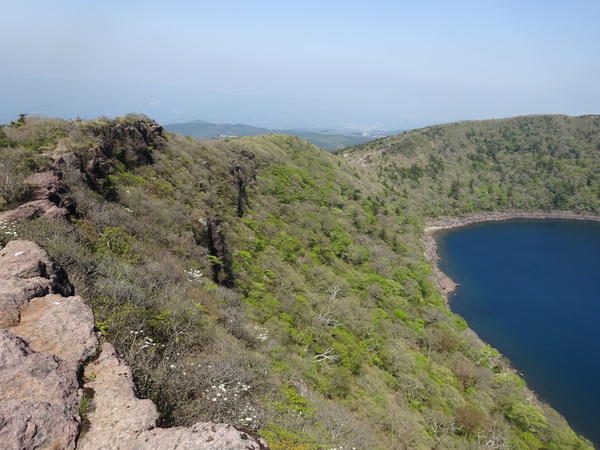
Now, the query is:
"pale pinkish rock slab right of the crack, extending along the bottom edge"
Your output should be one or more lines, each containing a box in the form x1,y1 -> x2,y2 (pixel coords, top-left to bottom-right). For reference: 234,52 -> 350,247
78,344 -> 267,450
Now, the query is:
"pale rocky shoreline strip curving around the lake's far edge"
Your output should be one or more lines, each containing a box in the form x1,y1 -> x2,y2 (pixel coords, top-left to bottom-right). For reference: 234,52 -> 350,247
423,211 -> 600,306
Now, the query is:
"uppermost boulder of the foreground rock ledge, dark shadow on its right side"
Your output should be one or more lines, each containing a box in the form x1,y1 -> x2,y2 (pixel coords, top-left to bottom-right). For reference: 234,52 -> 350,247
0,240 -> 73,328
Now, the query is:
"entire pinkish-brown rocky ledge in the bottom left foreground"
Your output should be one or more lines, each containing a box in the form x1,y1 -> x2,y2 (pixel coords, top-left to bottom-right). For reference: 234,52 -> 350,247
0,240 -> 267,450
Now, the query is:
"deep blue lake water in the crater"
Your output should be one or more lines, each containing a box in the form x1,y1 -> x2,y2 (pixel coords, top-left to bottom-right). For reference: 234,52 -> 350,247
436,219 -> 600,447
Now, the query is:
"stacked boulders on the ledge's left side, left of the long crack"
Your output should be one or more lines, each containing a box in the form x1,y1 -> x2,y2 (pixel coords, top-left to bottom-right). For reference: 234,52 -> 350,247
0,241 -> 98,449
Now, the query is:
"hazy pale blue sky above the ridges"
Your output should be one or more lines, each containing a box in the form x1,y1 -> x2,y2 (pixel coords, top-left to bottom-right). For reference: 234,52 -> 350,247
0,0 -> 600,127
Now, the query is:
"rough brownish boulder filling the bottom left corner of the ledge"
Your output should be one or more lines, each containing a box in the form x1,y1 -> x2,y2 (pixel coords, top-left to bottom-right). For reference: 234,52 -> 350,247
0,329 -> 80,450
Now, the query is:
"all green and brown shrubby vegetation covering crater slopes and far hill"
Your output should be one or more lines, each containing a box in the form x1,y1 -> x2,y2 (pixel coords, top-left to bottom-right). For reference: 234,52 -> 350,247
0,116 -> 599,449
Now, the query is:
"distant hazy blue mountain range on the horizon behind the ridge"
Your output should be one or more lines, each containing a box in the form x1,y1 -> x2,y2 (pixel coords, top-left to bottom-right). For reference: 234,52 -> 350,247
164,120 -> 405,151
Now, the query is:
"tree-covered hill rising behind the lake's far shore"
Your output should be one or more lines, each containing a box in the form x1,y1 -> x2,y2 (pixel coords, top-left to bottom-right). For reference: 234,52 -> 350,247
342,115 -> 600,217
